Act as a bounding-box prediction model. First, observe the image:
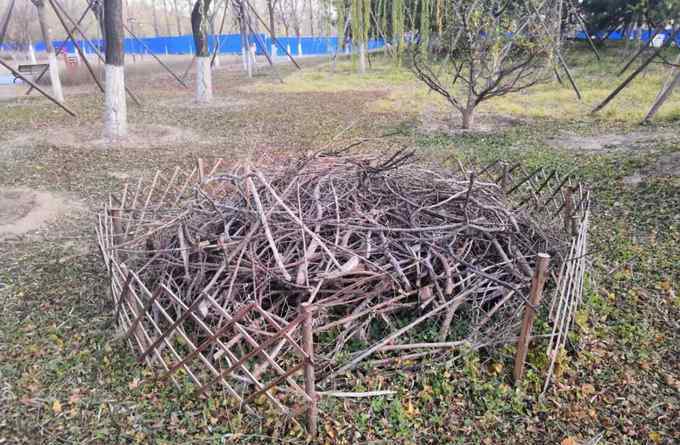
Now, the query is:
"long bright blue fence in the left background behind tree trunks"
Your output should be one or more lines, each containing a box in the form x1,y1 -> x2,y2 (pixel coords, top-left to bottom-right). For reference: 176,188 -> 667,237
2,34 -> 384,56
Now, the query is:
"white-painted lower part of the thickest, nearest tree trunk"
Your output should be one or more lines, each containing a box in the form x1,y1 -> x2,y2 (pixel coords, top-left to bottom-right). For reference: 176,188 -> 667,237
104,64 -> 127,140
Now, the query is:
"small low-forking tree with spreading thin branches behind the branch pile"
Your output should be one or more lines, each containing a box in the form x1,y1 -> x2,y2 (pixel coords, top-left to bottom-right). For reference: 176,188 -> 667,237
412,0 -> 555,129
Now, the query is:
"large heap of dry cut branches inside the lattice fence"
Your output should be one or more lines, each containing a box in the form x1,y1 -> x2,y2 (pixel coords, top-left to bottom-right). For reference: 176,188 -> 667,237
113,152 -> 568,378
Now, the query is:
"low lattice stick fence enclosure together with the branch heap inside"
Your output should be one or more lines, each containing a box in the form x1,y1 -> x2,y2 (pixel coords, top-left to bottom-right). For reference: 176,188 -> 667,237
97,152 -> 590,433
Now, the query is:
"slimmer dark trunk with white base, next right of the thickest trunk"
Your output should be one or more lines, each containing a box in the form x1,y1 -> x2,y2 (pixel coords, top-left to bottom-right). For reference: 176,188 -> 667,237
191,0 -> 212,103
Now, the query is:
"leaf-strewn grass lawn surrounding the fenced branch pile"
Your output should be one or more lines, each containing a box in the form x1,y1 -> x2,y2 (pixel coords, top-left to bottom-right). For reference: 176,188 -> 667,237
0,42 -> 680,445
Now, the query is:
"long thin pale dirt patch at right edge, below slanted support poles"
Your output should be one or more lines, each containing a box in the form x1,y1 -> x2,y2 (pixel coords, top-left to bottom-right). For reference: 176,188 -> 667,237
546,131 -> 676,151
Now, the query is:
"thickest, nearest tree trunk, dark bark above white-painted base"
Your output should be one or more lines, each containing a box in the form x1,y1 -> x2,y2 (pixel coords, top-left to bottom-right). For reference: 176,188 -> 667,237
104,0 -> 127,140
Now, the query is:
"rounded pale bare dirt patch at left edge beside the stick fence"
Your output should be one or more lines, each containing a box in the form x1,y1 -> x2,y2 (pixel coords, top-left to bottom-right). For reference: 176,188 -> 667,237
0,189 -> 78,240
